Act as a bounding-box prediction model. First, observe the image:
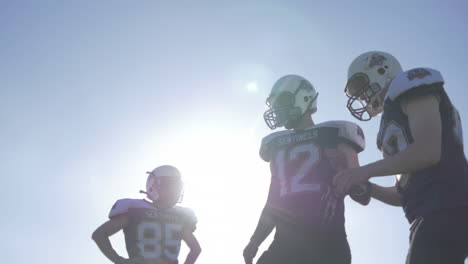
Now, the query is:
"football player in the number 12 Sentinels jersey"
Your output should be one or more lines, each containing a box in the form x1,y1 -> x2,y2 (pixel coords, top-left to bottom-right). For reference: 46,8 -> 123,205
243,75 -> 370,264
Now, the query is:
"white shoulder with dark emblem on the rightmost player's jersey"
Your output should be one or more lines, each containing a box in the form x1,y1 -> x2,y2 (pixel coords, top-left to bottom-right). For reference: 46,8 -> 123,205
385,68 -> 444,100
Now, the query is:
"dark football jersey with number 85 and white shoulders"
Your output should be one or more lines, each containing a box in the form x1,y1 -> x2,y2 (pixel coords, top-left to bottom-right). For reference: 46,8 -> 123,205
109,199 -> 197,263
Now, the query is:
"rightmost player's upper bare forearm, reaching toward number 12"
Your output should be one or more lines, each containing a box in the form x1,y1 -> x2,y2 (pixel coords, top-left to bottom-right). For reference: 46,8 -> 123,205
362,143 -> 440,177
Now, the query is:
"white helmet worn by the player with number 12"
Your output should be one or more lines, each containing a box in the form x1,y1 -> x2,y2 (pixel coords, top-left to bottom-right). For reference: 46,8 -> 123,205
263,75 -> 318,129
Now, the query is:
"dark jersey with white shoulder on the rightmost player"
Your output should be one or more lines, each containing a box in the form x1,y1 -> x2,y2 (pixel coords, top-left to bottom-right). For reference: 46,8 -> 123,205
377,68 -> 468,223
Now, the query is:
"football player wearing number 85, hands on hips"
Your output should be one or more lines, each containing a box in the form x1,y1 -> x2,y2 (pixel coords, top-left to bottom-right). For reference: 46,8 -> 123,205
92,165 -> 201,264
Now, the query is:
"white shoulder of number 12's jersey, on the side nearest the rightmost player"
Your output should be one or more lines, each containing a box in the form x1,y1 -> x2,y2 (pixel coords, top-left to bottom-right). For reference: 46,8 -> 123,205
315,120 -> 366,152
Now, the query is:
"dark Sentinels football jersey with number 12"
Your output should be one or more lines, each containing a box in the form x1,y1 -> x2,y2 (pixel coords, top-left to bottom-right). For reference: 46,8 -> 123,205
260,121 -> 365,235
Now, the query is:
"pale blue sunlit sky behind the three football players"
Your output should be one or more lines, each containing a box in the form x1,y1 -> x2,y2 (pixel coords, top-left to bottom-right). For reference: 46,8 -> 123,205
0,0 -> 468,264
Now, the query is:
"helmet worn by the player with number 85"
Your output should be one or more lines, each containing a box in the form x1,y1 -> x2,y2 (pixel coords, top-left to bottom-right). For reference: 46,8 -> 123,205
143,165 -> 183,202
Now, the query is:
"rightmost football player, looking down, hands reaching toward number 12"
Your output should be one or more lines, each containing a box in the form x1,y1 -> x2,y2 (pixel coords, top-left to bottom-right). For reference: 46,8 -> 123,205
334,51 -> 468,264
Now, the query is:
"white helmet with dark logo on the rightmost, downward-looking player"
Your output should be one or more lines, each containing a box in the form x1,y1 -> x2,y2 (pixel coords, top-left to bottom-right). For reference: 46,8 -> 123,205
345,51 -> 403,121
